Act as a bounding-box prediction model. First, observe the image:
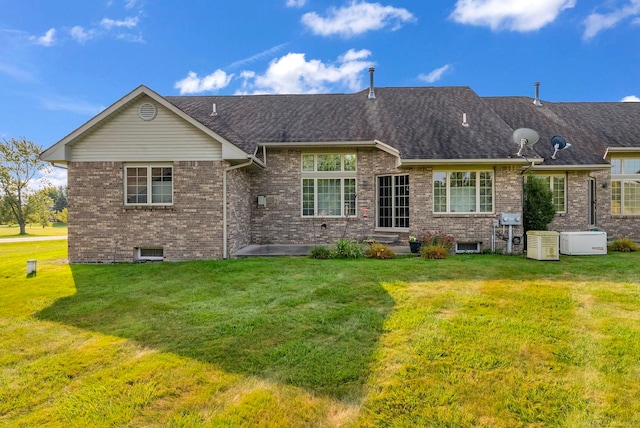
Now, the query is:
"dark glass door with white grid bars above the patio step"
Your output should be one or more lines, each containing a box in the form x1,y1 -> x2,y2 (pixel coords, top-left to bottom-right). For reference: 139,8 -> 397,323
378,175 -> 409,228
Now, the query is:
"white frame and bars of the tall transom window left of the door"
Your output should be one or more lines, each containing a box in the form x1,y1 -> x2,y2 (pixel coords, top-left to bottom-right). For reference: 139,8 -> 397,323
300,153 -> 358,218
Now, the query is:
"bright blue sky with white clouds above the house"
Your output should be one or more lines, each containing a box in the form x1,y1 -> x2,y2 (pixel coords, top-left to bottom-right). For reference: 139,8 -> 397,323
0,0 -> 640,186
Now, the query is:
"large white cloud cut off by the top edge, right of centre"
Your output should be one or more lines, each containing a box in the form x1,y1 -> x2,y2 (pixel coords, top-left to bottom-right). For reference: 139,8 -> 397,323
450,0 -> 576,32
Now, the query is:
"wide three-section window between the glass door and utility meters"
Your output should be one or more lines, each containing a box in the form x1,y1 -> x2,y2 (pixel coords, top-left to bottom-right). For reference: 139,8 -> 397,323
433,171 -> 493,213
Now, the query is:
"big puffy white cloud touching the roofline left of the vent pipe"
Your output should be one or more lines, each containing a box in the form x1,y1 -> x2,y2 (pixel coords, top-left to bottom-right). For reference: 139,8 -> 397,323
241,49 -> 372,94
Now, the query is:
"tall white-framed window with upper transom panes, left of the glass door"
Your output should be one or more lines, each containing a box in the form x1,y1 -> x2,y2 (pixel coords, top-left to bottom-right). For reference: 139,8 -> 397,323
302,153 -> 356,217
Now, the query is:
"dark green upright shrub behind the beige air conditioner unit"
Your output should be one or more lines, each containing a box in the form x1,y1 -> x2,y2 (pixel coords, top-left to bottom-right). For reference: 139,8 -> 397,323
523,175 -> 556,231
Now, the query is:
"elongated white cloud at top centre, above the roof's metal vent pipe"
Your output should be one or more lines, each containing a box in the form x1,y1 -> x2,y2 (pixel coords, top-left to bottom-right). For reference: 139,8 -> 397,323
302,0 -> 416,37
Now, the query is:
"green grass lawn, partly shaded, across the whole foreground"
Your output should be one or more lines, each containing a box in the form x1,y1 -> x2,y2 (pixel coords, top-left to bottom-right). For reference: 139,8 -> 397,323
0,241 -> 640,427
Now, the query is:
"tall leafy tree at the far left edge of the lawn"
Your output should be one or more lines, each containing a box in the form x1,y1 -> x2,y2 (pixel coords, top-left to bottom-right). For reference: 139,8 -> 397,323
0,137 -> 48,235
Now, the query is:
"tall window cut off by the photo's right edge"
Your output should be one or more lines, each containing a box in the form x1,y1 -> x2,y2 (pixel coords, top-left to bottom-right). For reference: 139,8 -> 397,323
611,158 -> 640,215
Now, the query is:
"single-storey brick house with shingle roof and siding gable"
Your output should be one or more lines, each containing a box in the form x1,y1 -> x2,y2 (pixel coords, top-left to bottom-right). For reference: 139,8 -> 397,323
41,73 -> 640,263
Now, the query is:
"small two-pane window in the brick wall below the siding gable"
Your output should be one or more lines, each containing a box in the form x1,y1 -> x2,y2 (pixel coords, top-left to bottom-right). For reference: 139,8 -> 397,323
125,165 -> 173,205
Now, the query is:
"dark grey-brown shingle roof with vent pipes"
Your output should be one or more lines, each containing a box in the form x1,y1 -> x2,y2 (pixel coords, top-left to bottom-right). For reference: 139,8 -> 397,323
166,87 -> 640,165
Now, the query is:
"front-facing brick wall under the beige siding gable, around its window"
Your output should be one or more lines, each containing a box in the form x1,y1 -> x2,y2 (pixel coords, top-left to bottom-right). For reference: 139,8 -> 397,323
68,161 -> 223,263
